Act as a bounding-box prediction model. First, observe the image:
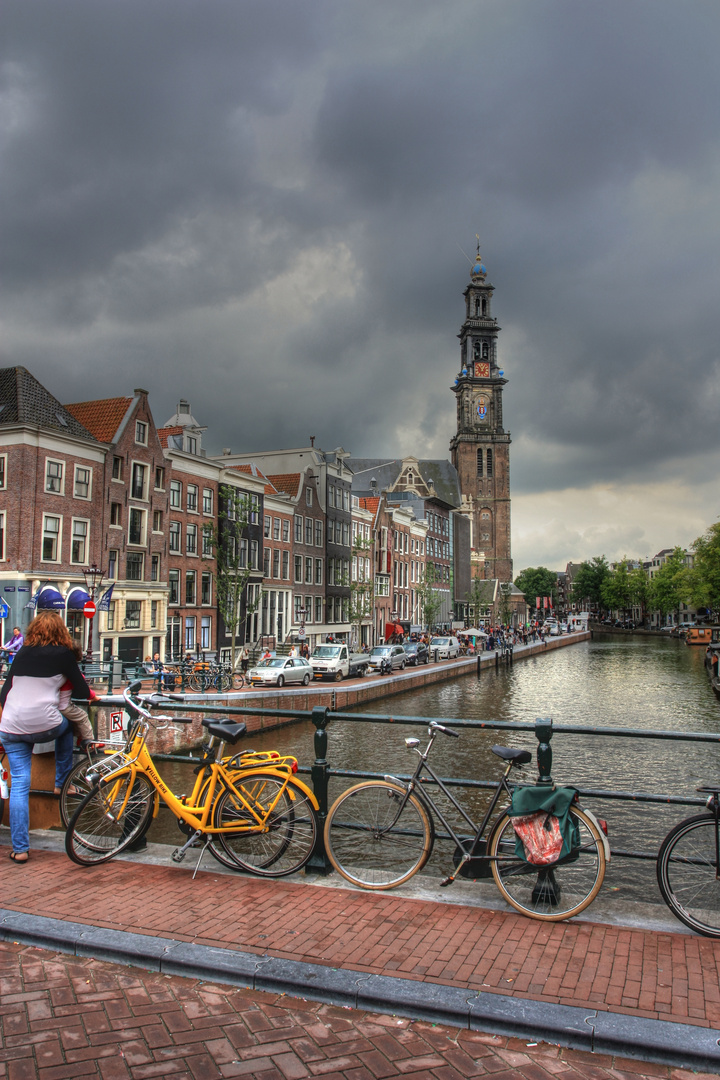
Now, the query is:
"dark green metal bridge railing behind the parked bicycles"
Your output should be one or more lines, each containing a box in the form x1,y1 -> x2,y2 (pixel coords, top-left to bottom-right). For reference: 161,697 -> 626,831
84,697 -> 720,873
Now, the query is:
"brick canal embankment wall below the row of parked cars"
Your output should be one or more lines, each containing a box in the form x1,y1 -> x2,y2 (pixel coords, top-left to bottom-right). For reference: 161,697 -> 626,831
93,632 -> 590,754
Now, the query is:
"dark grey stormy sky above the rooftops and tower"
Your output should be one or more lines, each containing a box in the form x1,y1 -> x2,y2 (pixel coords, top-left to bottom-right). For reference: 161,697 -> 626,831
0,0 -> 720,568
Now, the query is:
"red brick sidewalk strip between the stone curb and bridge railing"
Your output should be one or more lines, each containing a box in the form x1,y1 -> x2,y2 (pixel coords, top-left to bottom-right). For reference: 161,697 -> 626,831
1,851 -> 720,1027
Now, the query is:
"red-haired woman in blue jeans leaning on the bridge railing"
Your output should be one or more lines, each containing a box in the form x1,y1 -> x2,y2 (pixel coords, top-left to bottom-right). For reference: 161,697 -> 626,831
0,611 -> 91,865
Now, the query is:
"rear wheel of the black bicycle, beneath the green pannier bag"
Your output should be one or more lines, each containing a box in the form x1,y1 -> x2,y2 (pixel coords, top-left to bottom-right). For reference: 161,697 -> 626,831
488,807 -> 606,922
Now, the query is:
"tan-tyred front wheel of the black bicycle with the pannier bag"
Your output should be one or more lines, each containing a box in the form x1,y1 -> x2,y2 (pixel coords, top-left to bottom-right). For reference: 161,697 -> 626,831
325,780 -> 435,890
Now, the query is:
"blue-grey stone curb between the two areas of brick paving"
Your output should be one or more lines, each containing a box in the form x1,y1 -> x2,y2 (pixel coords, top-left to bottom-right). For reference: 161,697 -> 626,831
0,908 -> 720,1072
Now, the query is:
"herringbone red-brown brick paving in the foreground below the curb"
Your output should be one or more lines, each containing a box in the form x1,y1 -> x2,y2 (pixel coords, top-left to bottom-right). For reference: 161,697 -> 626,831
0,943 -> 711,1080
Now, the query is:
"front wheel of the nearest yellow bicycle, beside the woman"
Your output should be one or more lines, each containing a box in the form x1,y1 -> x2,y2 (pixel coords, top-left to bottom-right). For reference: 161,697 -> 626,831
65,773 -> 154,866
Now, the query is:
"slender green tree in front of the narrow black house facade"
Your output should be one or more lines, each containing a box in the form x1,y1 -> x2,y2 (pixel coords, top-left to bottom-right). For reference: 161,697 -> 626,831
203,484 -> 262,670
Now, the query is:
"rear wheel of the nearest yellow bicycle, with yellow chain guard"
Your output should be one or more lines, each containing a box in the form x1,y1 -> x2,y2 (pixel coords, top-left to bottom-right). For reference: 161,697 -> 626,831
213,772 -> 317,877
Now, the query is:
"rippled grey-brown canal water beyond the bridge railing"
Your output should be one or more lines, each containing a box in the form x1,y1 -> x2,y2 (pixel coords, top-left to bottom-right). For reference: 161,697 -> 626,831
147,635 -> 720,902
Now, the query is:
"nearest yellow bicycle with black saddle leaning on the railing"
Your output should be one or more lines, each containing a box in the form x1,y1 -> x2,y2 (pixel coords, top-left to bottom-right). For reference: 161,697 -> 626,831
65,683 -> 318,877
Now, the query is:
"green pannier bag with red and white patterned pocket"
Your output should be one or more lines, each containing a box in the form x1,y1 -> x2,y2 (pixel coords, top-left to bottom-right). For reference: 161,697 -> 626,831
507,784 -> 580,866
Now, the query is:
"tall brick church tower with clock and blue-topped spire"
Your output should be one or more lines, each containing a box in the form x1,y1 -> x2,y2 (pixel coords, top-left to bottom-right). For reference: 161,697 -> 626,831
450,245 -> 513,581
